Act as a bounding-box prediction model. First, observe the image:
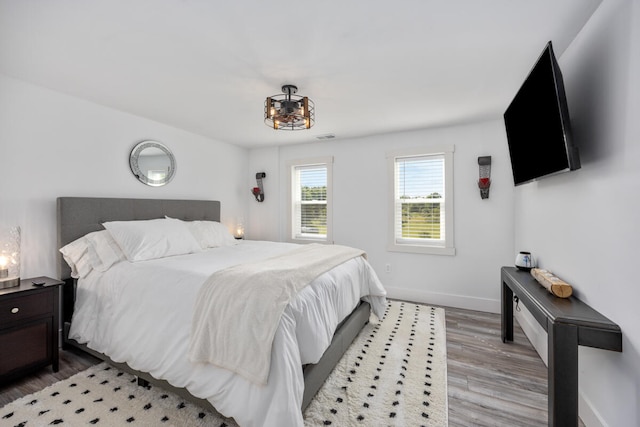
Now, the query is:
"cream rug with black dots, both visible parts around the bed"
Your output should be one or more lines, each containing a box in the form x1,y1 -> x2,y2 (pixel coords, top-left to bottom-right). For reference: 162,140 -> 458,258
0,301 -> 448,427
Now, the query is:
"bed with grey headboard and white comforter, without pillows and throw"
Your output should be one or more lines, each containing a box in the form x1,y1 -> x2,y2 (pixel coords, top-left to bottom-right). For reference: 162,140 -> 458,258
57,197 -> 386,426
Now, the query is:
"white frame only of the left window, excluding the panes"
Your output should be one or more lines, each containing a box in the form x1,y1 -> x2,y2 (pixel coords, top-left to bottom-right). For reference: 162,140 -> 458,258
286,156 -> 333,244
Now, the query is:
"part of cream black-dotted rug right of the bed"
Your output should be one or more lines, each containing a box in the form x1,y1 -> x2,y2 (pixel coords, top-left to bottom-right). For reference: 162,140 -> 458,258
305,301 -> 448,427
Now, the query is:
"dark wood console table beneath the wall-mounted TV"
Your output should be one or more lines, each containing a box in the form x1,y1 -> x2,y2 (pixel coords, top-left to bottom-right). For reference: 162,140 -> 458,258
500,267 -> 622,427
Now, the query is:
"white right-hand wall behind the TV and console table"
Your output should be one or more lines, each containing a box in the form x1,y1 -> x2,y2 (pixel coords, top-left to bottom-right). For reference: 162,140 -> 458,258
515,0 -> 640,427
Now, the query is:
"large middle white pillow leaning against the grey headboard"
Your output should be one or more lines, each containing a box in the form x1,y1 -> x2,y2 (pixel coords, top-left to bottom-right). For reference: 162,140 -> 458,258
102,219 -> 201,262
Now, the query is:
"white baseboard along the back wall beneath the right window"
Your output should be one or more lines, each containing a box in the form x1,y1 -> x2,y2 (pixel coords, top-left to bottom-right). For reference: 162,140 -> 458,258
385,286 -> 500,313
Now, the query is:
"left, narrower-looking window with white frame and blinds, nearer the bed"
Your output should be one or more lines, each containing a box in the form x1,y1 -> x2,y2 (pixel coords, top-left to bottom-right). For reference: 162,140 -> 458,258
288,157 -> 333,243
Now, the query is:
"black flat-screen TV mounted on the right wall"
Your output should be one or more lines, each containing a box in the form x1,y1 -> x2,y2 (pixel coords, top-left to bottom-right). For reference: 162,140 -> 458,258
504,42 -> 580,185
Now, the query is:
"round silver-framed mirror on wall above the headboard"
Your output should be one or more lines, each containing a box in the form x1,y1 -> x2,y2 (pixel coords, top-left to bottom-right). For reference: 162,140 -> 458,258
129,141 -> 176,187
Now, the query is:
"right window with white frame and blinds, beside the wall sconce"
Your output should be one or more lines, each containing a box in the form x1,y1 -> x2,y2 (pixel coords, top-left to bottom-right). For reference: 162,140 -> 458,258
387,146 -> 455,255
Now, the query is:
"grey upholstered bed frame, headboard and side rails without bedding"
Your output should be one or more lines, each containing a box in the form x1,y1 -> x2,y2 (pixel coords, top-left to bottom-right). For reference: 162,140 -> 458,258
57,197 -> 370,411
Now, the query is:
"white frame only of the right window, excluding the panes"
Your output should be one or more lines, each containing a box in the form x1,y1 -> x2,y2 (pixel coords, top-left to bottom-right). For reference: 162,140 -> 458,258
387,145 -> 456,255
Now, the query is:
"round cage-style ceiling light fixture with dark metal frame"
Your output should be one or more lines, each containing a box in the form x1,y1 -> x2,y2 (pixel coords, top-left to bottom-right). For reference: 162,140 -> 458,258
264,85 -> 316,130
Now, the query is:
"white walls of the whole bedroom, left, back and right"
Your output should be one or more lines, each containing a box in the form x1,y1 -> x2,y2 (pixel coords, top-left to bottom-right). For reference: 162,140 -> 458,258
8,5 -> 640,427
